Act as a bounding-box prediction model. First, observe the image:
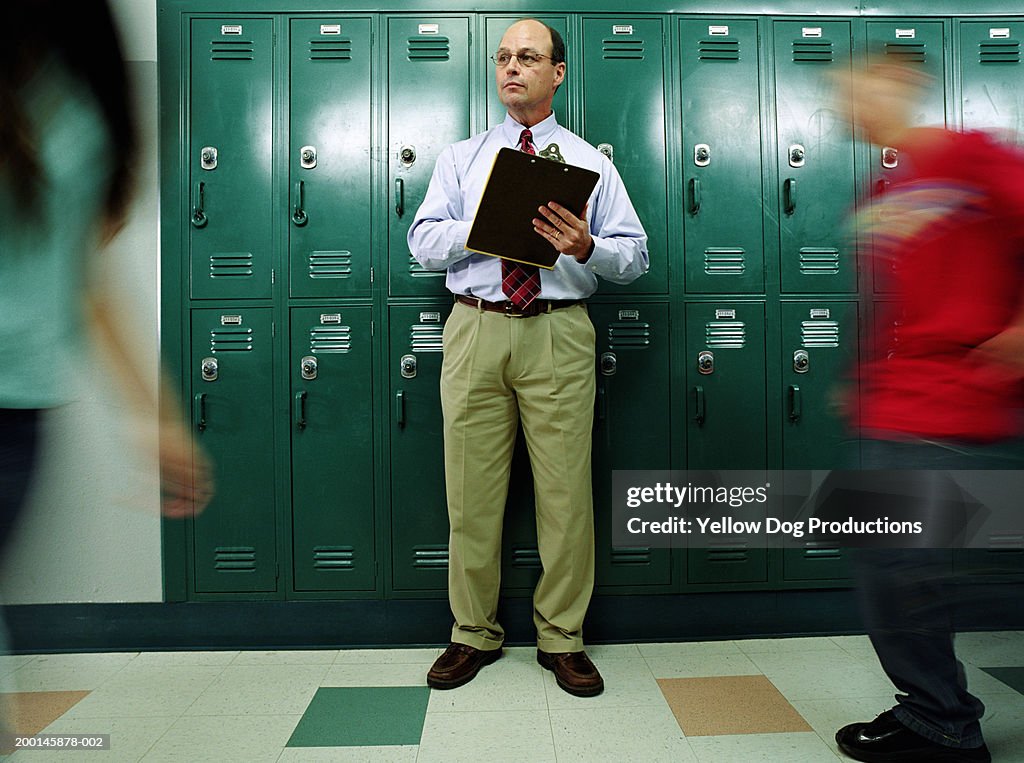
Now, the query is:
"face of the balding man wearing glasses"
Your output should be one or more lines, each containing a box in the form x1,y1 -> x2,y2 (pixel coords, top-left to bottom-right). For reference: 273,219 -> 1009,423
496,20 -> 565,116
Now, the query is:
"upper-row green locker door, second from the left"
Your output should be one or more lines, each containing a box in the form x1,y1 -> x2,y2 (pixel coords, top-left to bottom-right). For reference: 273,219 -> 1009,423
288,18 -> 373,297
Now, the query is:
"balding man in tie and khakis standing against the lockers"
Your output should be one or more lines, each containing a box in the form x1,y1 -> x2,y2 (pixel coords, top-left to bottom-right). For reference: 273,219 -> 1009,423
409,18 -> 648,696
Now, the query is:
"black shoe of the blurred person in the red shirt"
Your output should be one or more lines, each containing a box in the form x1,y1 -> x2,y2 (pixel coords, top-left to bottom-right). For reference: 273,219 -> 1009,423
836,710 -> 992,763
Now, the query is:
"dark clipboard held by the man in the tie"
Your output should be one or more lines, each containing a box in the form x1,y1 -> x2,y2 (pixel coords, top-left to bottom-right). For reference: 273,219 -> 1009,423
466,149 -> 600,270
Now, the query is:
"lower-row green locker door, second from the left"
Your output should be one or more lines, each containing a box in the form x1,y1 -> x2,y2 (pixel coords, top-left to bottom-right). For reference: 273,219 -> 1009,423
289,306 -> 375,591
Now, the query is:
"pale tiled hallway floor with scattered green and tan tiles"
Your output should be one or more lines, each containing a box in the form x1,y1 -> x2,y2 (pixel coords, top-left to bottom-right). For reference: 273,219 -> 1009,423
0,632 -> 1024,763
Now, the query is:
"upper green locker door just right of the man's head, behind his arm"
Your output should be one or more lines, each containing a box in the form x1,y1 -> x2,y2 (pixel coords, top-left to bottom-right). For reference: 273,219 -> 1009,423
583,17 -> 669,294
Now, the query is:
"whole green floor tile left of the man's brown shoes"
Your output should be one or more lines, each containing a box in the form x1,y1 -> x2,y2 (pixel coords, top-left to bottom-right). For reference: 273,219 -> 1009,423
288,686 -> 430,747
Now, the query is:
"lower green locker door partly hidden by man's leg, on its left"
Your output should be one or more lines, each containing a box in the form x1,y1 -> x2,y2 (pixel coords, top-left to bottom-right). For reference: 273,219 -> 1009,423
389,302 -> 451,591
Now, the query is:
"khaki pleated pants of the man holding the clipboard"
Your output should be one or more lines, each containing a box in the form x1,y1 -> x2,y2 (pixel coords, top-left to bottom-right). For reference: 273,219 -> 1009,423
440,303 -> 596,652
